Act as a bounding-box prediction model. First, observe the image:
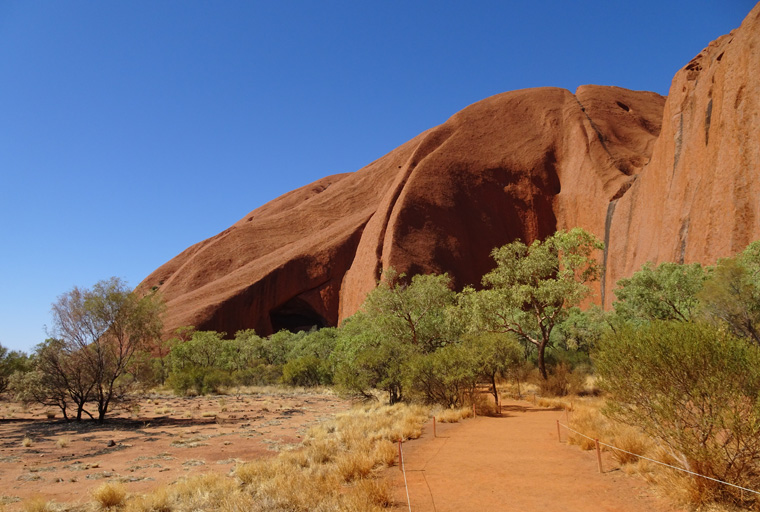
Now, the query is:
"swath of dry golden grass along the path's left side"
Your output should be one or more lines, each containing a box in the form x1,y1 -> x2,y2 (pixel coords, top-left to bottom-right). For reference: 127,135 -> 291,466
124,404 -> 430,512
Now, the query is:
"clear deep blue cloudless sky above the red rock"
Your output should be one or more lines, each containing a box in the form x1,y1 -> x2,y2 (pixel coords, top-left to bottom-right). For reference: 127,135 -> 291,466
0,0 -> 754,351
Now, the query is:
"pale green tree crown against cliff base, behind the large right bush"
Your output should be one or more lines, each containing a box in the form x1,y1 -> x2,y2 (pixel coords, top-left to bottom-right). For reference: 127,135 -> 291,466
613,263 -> 707,323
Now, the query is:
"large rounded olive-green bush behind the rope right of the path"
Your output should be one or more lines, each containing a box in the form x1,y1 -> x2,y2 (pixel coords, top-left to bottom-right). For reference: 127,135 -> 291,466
595,322 -> 760,502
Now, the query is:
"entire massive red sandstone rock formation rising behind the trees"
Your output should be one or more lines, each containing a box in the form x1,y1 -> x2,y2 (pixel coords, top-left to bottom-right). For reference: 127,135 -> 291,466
139,6 -> 760,340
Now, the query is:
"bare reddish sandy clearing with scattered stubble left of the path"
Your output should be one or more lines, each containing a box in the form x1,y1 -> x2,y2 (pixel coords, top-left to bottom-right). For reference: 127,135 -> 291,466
0,391 -> 351,511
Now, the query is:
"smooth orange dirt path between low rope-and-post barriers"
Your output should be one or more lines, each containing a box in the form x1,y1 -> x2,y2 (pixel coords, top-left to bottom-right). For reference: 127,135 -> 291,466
389,401 -> 684,512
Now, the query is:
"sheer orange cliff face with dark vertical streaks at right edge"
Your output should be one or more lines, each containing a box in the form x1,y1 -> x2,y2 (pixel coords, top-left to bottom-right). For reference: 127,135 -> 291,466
607,4 -> 760,304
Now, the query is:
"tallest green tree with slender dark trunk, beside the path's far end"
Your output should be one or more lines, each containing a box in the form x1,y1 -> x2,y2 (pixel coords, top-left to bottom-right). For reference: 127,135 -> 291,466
461,228 -> 604,379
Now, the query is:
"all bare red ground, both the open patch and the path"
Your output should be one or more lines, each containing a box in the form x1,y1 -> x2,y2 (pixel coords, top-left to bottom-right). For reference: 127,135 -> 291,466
0,392 -> 681,512
